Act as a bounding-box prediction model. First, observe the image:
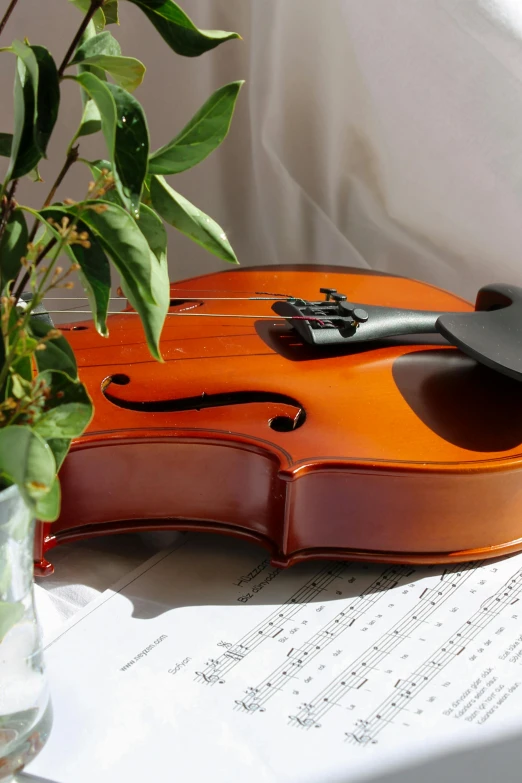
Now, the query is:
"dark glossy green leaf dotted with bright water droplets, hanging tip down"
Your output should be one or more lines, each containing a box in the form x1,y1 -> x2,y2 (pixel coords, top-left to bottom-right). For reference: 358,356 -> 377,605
74,73 -> 149,216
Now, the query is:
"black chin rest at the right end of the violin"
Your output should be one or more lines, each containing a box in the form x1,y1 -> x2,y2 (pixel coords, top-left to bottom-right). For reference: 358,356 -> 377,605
435,284 -> 522,380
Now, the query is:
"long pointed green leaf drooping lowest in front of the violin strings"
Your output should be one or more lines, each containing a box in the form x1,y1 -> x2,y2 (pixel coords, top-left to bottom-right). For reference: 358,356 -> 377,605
42,201 -> 167,360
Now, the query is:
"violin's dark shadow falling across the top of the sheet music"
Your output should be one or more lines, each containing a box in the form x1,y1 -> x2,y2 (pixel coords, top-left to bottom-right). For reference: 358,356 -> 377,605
99,533 -> 444,620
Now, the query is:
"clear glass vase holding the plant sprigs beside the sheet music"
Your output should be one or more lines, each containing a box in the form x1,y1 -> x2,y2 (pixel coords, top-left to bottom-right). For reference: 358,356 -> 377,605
0,486 -> 52,783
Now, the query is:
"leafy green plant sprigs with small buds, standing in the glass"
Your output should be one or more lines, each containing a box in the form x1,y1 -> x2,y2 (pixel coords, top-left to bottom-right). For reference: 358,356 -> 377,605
0,0 -> 242,520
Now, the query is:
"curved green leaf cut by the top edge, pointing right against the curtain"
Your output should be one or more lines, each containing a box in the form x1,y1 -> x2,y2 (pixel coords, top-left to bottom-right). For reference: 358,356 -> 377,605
126,0 -> 241,57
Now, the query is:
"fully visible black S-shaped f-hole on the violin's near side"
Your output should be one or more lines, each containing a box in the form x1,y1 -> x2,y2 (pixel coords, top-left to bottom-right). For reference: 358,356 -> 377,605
101,373 -> 306,432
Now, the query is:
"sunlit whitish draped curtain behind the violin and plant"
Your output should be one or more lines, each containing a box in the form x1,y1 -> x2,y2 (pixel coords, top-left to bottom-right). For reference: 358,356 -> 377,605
0,0 -> 522,298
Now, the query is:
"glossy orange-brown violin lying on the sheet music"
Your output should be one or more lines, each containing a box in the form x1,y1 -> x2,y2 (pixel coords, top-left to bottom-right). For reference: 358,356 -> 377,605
35,266 -> 522,573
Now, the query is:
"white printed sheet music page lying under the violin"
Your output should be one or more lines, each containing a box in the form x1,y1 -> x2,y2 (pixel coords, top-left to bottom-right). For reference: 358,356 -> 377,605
25,536 -> 522,783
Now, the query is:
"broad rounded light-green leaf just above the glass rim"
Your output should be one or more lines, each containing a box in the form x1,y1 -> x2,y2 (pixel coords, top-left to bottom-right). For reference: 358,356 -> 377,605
0,425 -> 56,508
